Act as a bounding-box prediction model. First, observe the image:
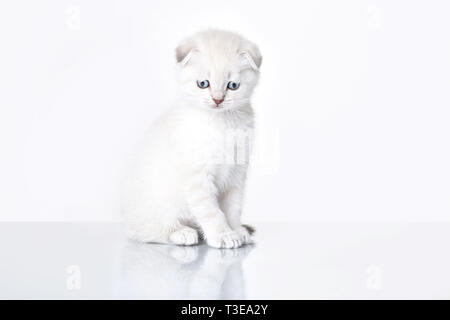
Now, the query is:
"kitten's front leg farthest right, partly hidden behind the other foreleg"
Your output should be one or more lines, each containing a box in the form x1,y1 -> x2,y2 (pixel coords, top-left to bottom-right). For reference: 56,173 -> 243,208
221,186 -> 252,244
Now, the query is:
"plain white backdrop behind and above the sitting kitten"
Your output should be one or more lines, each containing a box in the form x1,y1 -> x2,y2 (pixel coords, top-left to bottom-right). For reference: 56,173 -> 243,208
0,0 -> 450,222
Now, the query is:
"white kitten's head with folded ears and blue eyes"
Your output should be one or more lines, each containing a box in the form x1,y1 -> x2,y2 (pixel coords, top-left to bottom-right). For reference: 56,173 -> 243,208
176,30 -> 262,111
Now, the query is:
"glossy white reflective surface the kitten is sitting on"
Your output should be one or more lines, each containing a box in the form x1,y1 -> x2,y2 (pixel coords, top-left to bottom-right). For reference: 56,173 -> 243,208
0,222 -> 450,299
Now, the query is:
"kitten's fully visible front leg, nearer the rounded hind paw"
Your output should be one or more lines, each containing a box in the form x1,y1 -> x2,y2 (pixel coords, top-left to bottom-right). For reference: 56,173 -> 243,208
186,170 -> 242,248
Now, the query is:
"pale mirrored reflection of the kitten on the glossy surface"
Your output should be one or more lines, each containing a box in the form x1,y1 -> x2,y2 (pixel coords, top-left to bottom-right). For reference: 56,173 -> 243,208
120,242 -> 252,299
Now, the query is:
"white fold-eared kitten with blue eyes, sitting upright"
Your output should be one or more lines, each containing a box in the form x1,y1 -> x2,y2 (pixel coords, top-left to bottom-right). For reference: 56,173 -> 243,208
123,30 -> 261,248
